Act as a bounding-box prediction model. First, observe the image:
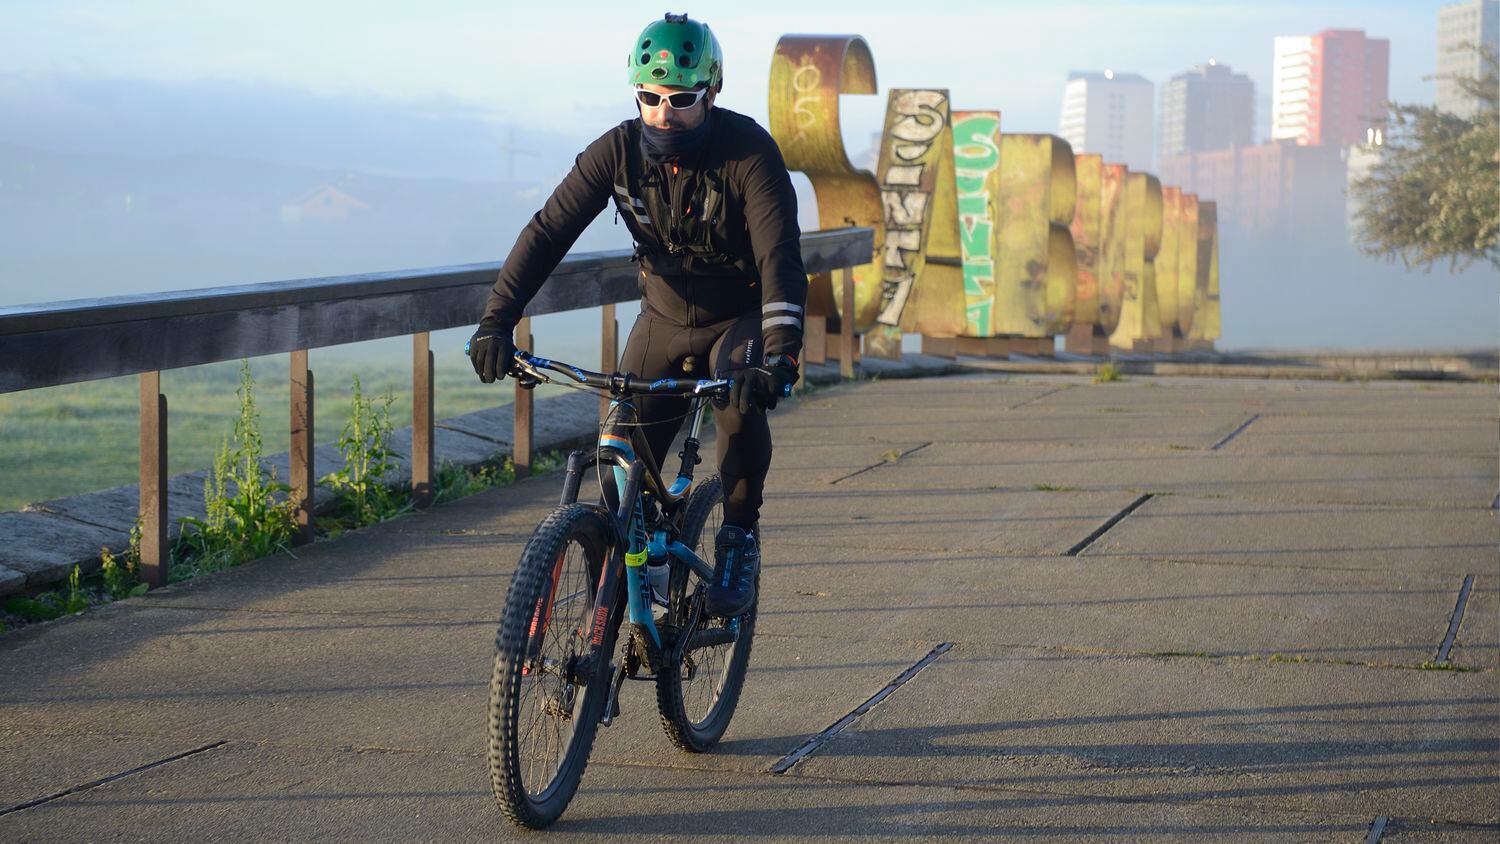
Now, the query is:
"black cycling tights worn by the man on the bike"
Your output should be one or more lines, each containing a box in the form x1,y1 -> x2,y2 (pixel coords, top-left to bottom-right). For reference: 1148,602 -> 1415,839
620,310 -> 771,531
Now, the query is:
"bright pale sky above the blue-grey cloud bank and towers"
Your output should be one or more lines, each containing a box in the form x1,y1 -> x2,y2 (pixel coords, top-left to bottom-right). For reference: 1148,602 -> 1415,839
0,0 -> 1443,146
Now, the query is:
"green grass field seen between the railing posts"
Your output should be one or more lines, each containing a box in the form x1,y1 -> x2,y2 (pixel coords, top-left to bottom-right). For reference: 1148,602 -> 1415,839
0,351 -> 561,510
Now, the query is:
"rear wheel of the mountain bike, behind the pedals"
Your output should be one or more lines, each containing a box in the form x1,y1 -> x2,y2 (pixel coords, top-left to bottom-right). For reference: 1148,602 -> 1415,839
657,477 -> 759,753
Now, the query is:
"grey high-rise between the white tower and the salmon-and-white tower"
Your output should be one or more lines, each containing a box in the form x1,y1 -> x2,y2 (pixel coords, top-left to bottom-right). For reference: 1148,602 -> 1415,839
1157,58 -> 1256,159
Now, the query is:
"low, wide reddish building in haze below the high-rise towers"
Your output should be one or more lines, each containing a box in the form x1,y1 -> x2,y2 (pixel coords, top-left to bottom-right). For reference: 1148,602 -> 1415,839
1158,141 -> 1349,241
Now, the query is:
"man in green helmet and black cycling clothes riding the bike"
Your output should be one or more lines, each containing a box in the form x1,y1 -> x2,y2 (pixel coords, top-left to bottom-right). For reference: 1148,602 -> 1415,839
470,13 -> 807,616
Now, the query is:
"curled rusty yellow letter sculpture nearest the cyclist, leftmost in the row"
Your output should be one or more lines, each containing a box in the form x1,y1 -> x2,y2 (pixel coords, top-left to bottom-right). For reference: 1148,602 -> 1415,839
770,34 -> 885,361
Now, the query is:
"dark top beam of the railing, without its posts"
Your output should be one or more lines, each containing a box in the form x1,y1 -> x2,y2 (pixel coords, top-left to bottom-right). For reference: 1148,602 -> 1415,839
0,228 -> 875,393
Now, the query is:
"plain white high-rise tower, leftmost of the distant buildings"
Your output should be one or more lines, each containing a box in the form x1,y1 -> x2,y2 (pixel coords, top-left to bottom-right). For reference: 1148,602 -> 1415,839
1058,70 -> 1155,171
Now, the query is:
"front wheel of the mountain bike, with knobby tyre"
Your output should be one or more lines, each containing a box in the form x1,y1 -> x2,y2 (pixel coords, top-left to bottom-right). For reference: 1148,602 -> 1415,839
489,504 -> 618,829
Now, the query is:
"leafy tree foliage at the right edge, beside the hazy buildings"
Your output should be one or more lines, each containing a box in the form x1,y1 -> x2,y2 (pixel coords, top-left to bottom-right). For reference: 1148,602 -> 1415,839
1350,48 -> 1500,271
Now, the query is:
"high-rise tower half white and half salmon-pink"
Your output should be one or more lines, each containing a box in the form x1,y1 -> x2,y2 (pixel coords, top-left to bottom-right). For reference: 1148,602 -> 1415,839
1271,30 -> 1391,147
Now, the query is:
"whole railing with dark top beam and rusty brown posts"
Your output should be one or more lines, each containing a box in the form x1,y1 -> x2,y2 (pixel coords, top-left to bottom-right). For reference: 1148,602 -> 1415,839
0,228 -> 875,586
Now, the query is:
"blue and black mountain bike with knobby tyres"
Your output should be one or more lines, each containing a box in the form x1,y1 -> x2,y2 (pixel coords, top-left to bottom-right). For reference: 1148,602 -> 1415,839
489,351 -> 756,829
